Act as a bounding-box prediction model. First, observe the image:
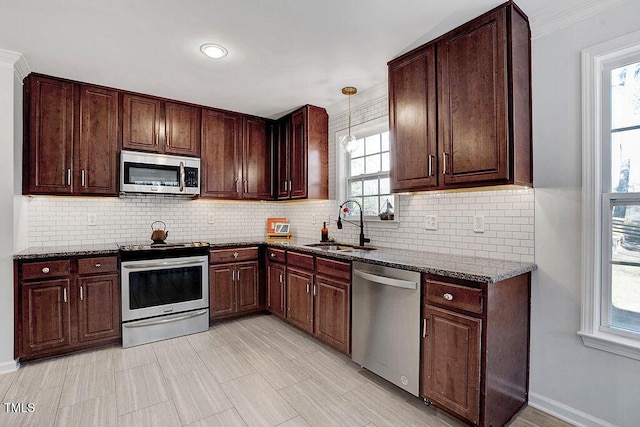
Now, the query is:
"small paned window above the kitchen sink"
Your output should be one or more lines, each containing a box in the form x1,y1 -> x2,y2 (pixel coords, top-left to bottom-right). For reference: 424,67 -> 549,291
336,116 -> 398,223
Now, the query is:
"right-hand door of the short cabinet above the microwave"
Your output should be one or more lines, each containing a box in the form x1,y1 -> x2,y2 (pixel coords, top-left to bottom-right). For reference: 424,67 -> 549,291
164,102 -> 200,157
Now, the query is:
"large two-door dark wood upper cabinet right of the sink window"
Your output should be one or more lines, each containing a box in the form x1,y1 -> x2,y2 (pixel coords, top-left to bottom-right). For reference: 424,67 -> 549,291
388,3 -> 533,191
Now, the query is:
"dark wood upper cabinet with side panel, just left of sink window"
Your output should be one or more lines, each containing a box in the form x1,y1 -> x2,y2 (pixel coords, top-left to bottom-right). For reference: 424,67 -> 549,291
274,105 -> 329,200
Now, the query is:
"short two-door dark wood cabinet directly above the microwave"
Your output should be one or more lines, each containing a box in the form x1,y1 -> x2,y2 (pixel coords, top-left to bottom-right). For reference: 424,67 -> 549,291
122,93 -> 200,157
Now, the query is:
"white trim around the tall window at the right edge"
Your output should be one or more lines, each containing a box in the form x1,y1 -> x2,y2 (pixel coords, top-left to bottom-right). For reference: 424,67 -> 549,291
578,32 -> 640,360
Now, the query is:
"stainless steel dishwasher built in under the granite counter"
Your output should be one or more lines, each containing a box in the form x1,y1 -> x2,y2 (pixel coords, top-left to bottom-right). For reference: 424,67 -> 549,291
351,262 -> 420,396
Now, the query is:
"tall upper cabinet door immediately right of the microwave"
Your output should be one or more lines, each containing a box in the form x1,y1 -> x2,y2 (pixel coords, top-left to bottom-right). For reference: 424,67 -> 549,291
200,109 -> 242,199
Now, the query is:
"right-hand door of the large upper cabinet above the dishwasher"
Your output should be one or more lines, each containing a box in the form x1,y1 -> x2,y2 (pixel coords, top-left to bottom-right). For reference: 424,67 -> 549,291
437,8 -> 509,184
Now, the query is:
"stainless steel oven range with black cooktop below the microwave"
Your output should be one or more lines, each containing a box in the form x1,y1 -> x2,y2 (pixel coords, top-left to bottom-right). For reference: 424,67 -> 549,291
120,242 -> 209,348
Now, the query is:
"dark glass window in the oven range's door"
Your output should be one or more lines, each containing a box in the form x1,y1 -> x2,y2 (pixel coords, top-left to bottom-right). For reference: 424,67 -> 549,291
129,267 -> 202,310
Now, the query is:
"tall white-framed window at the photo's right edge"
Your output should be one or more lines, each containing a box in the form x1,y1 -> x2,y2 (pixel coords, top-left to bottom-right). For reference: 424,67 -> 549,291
579,29 -> 640,359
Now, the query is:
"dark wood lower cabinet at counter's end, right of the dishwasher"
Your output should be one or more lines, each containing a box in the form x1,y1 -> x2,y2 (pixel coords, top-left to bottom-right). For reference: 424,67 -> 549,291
421,273 -> 531,426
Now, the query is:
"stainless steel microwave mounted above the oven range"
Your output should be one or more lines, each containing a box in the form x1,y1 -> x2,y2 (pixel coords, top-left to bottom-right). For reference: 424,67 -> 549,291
120,151 -> 200,196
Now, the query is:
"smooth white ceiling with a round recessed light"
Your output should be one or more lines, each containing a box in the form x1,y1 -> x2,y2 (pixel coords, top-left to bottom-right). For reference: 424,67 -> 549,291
0,0 -> 593,118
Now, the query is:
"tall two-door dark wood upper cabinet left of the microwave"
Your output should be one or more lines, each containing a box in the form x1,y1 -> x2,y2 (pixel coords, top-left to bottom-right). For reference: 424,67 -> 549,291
23,74 -> 118,196
